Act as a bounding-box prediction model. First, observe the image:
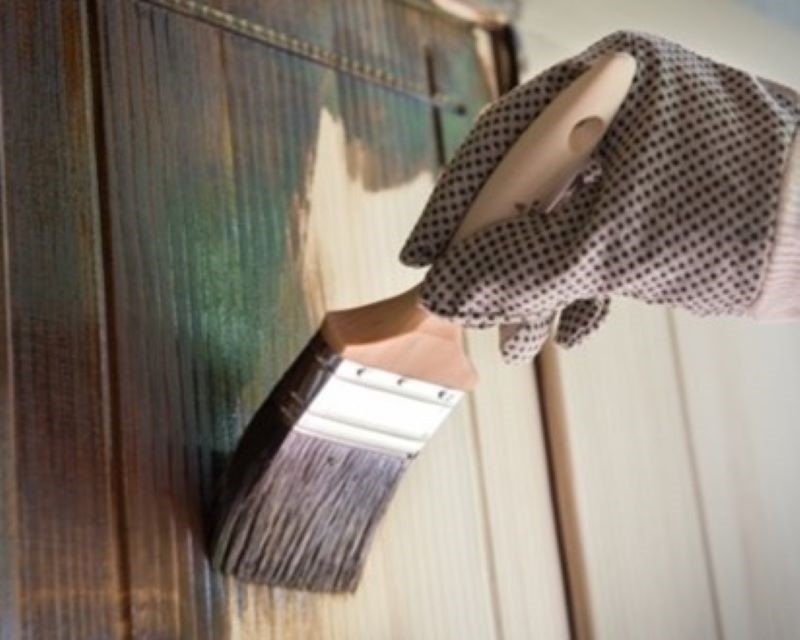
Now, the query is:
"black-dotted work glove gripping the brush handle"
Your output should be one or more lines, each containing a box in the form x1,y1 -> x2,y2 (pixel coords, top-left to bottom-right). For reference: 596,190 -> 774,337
401,32 -> 800,362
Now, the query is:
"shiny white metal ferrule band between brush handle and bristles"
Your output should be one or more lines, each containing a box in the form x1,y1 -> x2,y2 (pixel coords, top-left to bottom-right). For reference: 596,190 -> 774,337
294,358 -> 464,457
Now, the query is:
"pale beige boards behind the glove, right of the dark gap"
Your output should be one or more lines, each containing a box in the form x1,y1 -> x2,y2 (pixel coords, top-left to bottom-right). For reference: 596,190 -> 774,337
518,5 -> 800,640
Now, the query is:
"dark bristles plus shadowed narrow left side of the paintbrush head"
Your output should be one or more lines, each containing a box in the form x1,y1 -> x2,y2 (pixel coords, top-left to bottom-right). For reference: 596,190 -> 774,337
211,334 -> 408,591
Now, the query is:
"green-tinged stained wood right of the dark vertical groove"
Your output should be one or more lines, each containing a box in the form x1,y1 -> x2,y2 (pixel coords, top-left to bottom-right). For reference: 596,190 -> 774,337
76,0 -> 488,638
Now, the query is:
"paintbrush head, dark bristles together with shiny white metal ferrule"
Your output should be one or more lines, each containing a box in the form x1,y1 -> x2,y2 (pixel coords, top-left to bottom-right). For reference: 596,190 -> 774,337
211,333 -> 461,591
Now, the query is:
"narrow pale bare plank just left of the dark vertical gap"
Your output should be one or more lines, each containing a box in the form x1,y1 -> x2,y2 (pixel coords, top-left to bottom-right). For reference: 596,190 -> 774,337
467,331 -> 570,640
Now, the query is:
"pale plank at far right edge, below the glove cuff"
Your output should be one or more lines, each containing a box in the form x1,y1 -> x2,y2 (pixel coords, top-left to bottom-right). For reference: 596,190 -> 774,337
674,313 -> 800,640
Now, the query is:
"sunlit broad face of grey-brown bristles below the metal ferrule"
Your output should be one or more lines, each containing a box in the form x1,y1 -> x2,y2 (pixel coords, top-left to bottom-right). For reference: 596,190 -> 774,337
215,432 -> 407,591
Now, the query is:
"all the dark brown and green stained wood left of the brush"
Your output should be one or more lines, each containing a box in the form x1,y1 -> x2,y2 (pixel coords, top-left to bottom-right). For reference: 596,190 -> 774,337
0,0 -> 504,638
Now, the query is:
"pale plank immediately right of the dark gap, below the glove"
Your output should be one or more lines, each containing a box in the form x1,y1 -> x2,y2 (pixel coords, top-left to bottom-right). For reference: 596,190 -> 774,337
542,300 -> 720,640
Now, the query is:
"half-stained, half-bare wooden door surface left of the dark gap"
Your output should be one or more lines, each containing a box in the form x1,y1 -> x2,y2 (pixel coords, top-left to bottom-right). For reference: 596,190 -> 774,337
0,0 -> 567,639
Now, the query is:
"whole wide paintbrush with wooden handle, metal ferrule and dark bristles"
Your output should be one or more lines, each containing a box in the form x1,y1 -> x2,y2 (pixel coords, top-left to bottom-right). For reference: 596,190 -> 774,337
211,53 -> 636,591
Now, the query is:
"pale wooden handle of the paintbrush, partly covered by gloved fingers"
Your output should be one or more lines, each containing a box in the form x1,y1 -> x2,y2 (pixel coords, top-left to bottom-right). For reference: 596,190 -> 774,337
322,53 -> 636,389
